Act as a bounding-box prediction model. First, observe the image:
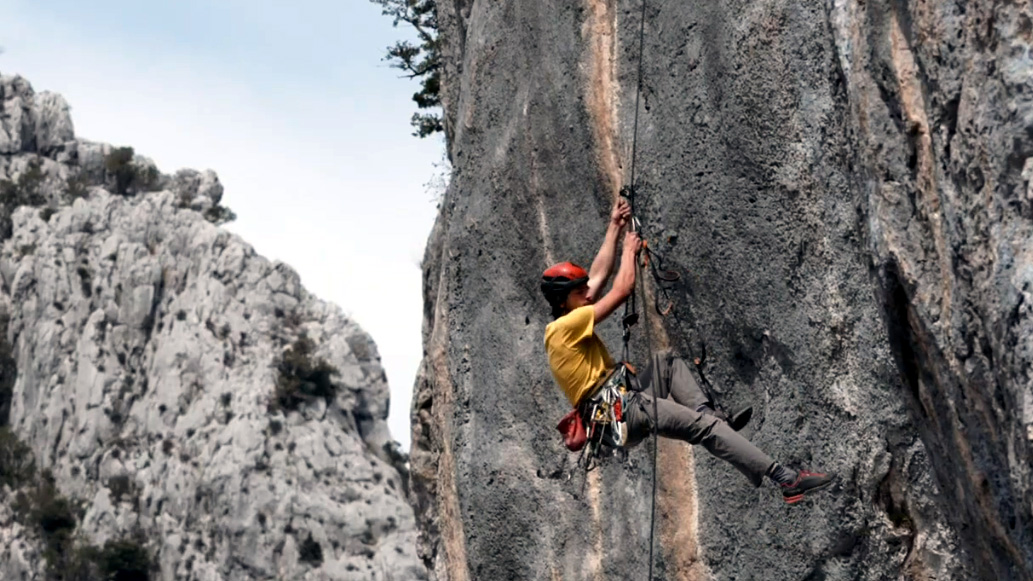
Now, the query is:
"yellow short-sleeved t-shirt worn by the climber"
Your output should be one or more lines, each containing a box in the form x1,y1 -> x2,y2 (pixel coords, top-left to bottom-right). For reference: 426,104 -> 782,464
545,305 -> 614,405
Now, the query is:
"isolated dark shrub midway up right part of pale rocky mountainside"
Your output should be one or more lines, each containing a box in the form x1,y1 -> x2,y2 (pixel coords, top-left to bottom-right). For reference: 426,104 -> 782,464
269,334 -> 339,414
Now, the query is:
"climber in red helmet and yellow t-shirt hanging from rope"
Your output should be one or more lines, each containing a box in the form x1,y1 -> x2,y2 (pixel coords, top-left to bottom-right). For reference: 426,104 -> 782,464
541,197 -> 832,503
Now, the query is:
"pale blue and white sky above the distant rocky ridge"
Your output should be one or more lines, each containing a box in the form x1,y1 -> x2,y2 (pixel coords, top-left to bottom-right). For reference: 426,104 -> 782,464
0,0 -> 444,450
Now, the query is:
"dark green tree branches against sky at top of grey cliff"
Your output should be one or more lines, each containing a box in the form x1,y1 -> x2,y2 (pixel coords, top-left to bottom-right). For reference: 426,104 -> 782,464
370,0 -> 444,137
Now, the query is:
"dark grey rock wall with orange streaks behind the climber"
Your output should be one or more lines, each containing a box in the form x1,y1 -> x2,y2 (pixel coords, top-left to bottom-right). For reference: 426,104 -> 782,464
412,0 -> 1033,581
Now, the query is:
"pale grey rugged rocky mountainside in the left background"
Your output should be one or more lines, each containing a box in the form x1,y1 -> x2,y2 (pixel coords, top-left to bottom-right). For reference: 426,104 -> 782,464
0,77 -> 426,580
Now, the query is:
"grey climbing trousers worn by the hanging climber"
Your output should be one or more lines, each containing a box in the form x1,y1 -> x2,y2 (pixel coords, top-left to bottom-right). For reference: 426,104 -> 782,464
625,351 -> 775,486
